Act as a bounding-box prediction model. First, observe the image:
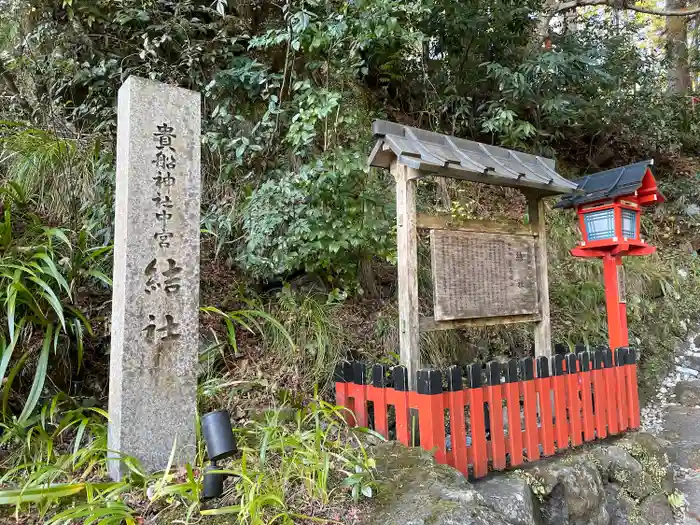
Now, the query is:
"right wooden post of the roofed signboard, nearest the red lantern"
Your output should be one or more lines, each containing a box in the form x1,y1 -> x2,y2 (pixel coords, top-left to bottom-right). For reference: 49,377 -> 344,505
525,194 -> 552,357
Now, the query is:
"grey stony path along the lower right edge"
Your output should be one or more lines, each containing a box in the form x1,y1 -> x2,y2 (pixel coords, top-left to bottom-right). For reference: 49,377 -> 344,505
642,336 -> 700,525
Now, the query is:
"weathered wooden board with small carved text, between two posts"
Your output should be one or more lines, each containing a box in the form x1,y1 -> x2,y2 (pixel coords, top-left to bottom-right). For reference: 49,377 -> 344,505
430,230 -> 538,321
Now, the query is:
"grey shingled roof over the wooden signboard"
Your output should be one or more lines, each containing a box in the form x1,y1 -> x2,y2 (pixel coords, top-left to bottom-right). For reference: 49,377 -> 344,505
369,120 -> 577,195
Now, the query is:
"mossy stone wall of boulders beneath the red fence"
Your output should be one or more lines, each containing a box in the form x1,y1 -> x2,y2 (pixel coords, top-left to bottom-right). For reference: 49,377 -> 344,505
364,433 -> 674,525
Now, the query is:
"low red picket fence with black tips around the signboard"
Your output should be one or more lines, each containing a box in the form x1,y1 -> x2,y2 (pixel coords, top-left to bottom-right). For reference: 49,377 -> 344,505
336,348 -> 639,478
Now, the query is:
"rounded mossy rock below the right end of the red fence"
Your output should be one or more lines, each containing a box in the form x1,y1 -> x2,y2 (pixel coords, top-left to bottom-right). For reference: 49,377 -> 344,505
591,445 -> 653,499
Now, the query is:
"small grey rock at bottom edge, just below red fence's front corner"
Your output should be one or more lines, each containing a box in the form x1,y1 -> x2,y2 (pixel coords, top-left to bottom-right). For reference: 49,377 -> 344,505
474,474 -> 539,525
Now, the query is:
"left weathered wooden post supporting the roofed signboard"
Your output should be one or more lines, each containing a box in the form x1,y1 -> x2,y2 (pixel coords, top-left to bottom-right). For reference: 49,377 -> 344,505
391,161 -> 420,391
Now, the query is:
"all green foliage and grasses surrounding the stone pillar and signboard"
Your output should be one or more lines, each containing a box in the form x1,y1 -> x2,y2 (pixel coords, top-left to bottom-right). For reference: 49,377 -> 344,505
0,0 -> 700,523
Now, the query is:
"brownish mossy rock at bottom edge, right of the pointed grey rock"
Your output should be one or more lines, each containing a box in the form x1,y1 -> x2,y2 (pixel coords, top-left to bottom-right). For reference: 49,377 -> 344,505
529,461 -> 610,525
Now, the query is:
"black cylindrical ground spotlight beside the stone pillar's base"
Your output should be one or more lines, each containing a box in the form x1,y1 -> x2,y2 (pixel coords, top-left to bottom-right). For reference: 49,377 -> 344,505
202,410 -> 238,499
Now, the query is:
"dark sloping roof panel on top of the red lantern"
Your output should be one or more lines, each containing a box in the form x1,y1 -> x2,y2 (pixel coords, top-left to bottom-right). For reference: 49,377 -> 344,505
555,160 -> 663,209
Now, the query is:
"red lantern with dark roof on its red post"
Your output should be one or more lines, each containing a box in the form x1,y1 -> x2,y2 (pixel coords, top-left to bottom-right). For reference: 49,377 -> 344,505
556,160 -> 665,348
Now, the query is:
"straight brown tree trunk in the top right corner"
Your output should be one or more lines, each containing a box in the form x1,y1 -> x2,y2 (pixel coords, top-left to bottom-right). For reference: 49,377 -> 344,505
666,0 -> 691,94
